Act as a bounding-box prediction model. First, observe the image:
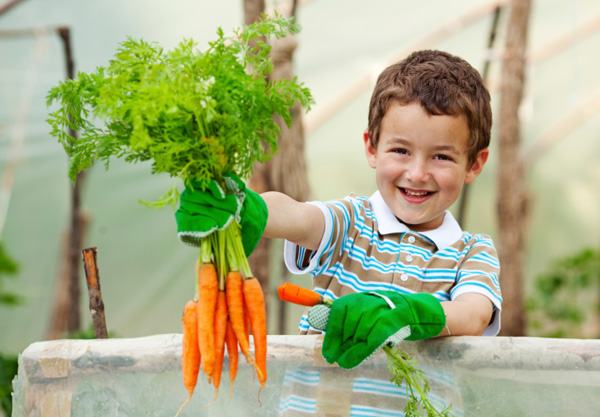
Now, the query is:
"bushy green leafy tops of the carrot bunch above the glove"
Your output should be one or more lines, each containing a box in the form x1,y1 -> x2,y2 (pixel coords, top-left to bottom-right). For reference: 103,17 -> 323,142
47,15 -> 313,207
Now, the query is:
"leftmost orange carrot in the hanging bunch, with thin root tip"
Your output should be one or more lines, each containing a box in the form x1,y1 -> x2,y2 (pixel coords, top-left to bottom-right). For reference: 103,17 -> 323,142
175,300 -> 200,417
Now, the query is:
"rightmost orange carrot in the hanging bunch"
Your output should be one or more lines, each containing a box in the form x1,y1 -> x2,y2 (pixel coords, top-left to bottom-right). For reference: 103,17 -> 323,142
243,277 -> 267,389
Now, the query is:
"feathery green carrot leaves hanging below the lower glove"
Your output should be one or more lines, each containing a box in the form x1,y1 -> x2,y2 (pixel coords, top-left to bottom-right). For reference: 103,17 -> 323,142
383,346 -> 452,417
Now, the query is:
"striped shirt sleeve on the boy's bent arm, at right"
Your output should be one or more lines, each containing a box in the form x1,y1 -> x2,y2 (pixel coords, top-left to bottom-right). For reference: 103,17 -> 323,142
450,235 -> 502,336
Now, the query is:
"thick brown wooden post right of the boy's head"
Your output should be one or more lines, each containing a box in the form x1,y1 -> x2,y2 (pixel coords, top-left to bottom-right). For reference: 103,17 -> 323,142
496,0 -> 532,336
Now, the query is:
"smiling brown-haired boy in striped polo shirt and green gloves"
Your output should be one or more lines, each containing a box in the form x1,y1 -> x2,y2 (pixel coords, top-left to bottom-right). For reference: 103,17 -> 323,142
178,51 -> 502,368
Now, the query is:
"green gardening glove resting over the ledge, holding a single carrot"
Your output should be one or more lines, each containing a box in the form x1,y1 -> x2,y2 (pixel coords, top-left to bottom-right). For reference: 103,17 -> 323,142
316,291 -> 446,369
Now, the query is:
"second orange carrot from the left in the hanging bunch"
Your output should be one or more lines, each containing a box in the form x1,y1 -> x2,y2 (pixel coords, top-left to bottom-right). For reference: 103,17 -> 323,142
196,262 -> 219,383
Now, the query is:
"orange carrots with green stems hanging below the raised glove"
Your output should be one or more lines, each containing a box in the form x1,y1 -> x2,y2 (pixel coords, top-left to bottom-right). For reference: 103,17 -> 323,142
176,222 -> 267,416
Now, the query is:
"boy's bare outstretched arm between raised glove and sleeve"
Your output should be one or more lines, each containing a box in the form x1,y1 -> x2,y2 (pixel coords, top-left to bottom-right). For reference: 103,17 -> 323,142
261,191 -> 325,250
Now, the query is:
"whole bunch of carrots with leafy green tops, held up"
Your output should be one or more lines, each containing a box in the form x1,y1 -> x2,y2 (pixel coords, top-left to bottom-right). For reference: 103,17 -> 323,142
47,13 -> 313,414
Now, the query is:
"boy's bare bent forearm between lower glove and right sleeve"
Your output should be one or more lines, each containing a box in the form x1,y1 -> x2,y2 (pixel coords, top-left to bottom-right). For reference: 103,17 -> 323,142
439,293 -> 494,336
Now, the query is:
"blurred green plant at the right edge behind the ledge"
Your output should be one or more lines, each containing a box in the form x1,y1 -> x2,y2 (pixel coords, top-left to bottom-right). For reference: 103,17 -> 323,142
526,248 -> 600,338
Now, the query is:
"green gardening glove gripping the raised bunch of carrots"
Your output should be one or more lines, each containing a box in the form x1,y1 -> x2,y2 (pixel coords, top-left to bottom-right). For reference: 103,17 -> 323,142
175,174 -> 268,256
